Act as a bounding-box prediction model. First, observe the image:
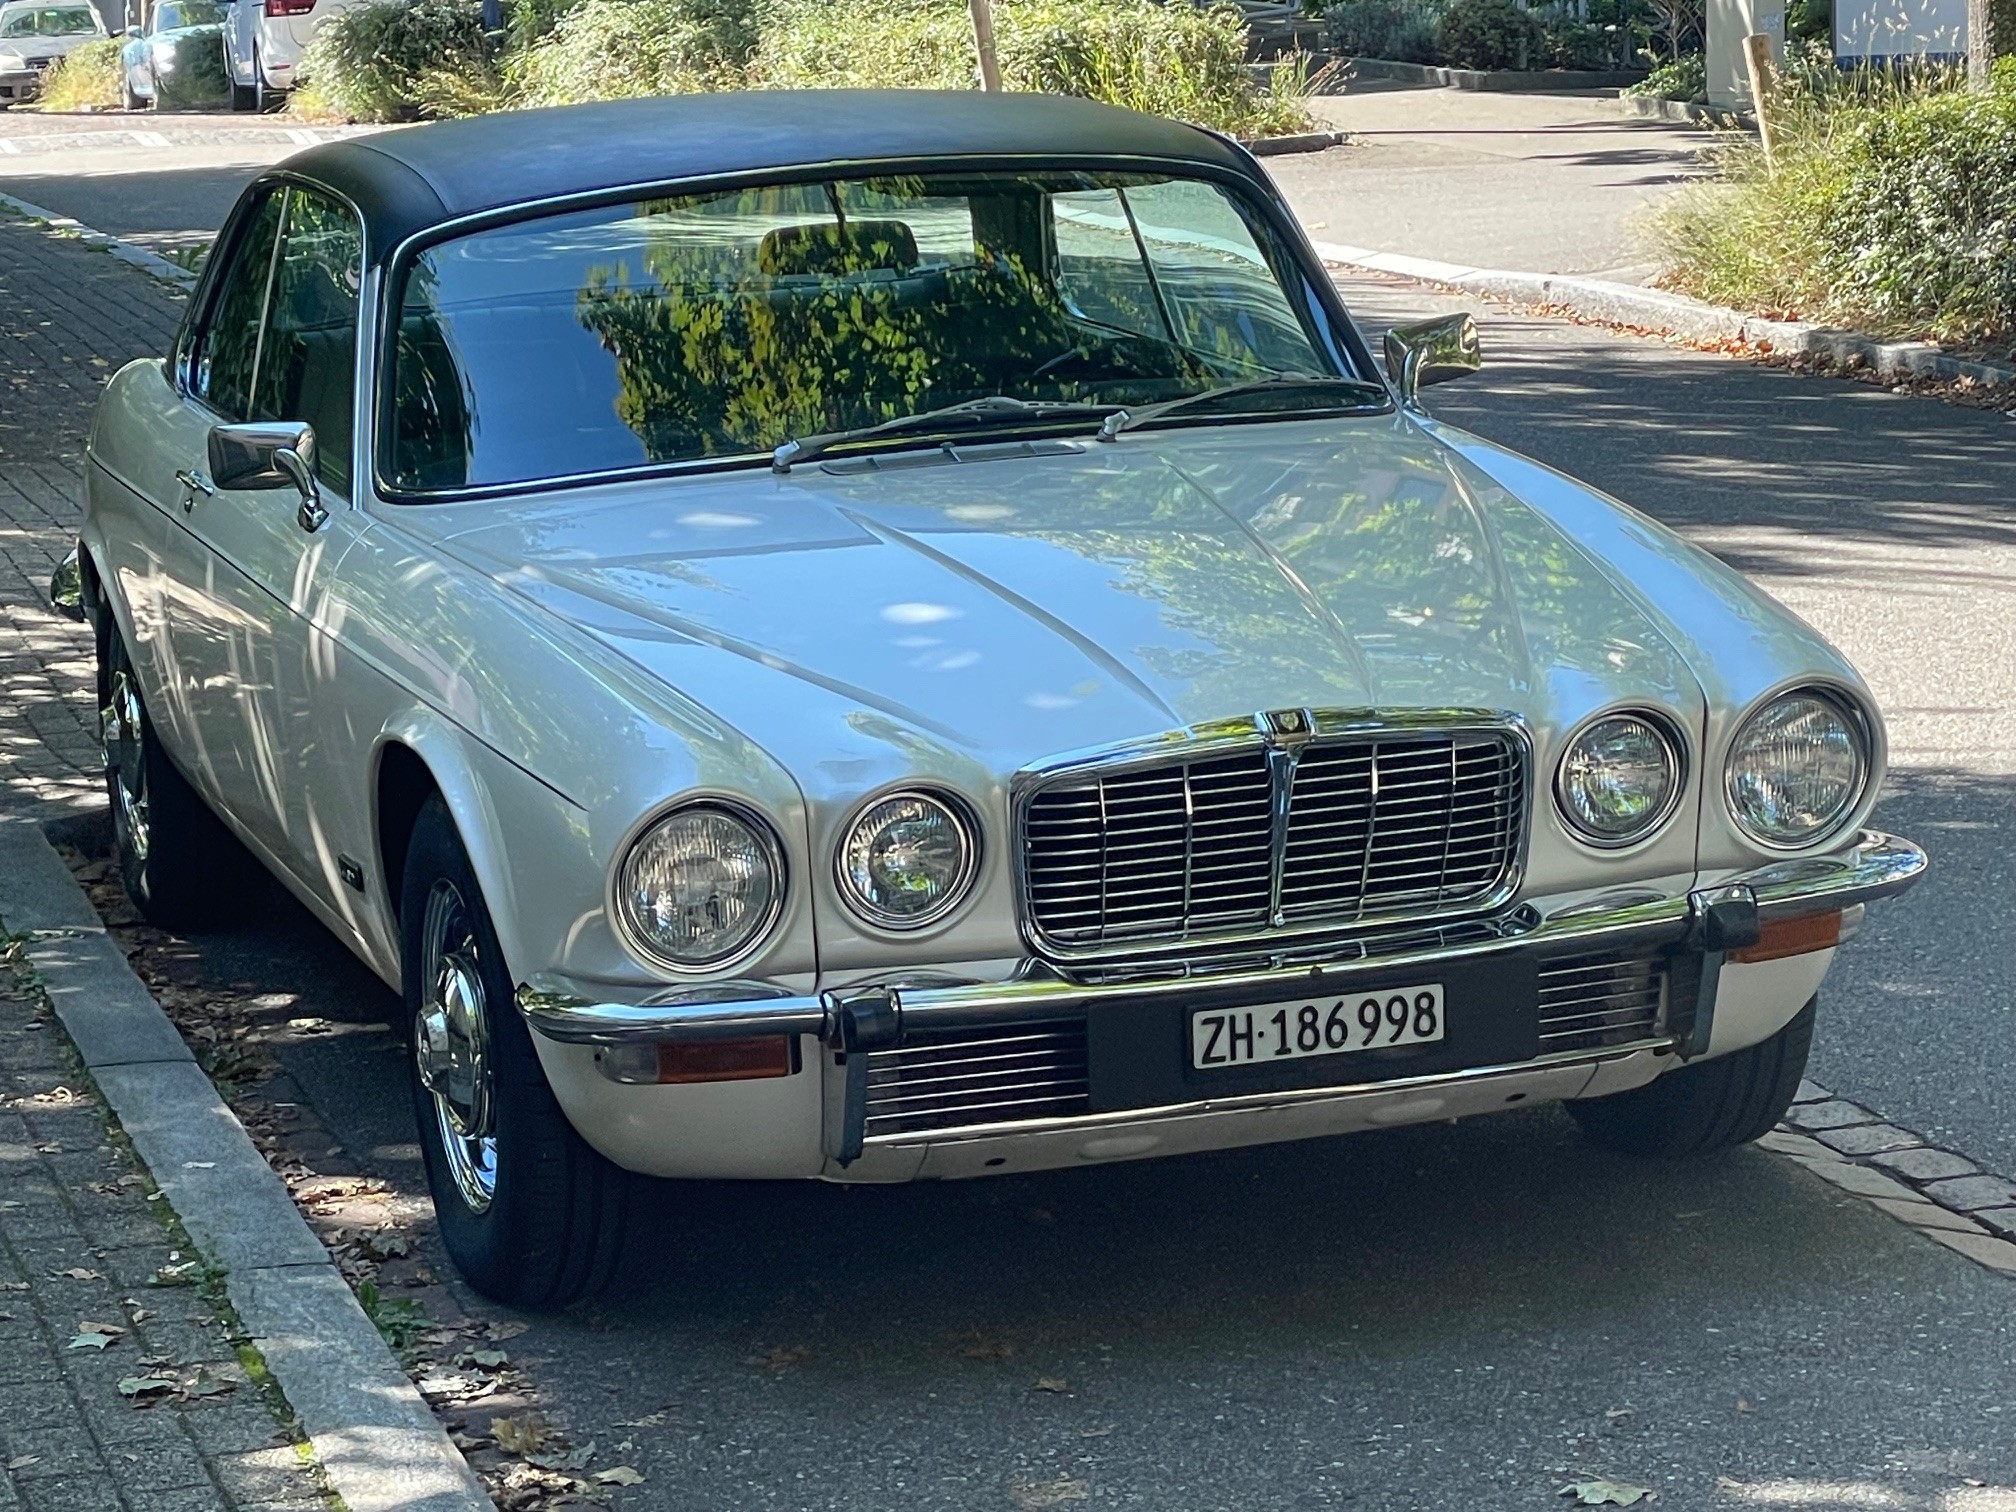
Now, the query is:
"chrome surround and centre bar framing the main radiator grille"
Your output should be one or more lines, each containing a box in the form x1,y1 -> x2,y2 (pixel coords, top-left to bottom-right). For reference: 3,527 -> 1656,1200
1008,710 -> 1534,962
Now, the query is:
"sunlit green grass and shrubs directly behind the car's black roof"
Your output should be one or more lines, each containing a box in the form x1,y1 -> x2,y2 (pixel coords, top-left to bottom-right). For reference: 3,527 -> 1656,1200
302,0 -> 1314,137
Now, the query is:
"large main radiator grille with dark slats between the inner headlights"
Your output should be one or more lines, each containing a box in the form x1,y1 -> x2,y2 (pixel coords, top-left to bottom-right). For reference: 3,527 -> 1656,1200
1022,732 -> 1526,952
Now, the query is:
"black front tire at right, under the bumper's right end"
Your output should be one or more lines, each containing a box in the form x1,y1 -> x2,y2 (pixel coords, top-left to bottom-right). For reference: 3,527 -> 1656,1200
1568,998 -> 1820,1159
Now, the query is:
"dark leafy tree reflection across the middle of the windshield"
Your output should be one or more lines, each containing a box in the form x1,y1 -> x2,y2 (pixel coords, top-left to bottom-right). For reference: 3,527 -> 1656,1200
577,177 -> 1290,460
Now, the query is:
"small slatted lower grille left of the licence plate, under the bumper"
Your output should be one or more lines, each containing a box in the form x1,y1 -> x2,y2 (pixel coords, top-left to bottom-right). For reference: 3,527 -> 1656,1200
865,1018 -> 1091,1135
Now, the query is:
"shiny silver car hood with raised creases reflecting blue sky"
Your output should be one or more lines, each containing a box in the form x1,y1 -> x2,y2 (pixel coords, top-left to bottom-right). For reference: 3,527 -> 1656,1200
421,419 -> 1704,794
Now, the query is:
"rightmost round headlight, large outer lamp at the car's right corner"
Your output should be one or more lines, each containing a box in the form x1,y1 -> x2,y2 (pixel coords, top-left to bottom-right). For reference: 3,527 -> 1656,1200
1728,691 -> 1869,849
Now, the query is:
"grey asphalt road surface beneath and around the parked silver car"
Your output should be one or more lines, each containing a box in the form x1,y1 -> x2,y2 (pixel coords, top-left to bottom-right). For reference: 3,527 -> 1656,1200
10,109 -> 2016,1512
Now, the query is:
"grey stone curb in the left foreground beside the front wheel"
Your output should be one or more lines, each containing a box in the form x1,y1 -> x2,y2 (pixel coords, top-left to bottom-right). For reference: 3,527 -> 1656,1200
0,816 -> 494,1512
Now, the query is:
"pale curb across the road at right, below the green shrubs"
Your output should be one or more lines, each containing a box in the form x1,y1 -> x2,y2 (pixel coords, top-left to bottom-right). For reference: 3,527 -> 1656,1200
1314,242 -> 2016,387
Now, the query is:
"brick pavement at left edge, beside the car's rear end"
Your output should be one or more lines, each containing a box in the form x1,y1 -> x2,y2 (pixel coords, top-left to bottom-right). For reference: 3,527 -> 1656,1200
0,212 -> 181,818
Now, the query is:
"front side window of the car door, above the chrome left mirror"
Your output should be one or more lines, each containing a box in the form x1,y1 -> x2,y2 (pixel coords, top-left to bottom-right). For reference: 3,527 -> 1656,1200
250,190 -> 363,496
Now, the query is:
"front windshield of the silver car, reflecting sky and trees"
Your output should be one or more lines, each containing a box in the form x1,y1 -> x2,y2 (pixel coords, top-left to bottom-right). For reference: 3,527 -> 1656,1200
381,171 -> 1363,492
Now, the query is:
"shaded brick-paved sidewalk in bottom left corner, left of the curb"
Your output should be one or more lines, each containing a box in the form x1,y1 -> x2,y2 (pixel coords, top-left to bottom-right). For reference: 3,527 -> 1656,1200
0,954 -> 327,1512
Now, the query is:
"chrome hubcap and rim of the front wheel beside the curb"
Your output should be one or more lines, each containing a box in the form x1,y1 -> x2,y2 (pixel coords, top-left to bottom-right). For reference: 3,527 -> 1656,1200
413,881 -> 498,1214
